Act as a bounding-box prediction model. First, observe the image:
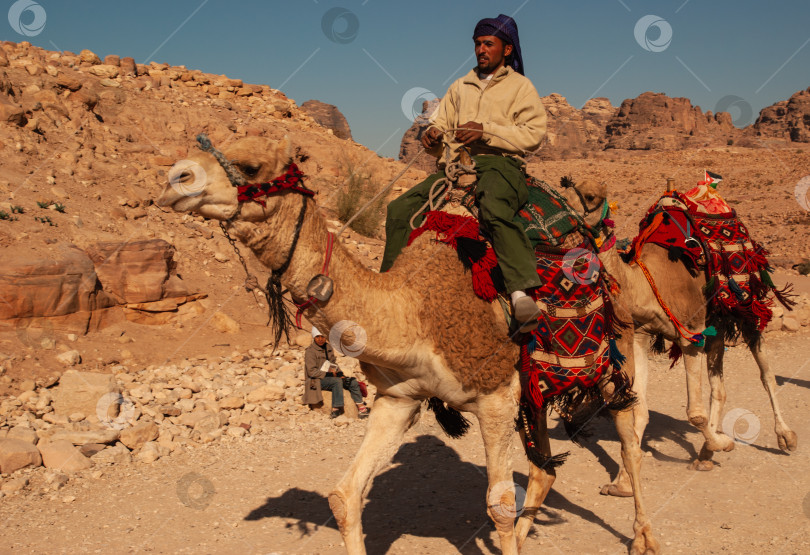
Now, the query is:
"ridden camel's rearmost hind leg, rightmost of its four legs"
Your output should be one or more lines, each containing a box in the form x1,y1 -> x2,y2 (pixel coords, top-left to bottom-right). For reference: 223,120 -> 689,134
613,410 -> 660,555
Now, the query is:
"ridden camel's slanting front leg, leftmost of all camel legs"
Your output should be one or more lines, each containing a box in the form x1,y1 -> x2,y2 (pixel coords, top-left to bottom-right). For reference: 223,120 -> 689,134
329,395 -> 421,555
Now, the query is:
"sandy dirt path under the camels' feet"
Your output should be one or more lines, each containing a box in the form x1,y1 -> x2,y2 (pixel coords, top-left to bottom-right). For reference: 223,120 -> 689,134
0,333 -> 810,554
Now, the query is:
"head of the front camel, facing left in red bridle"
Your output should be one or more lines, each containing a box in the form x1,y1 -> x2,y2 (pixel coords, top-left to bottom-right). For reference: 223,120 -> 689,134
156,137 -> 292,220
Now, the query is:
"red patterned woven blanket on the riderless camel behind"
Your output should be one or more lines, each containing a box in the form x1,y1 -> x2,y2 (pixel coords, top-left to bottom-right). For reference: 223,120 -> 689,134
630,191 -> 794,340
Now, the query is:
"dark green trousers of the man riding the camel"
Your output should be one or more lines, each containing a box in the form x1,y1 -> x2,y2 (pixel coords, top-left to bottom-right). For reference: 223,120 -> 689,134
380,155 -> 540,293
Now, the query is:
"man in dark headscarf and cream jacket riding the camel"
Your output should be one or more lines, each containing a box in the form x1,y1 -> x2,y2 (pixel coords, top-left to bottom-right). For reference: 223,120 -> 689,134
380,14 -> 546,331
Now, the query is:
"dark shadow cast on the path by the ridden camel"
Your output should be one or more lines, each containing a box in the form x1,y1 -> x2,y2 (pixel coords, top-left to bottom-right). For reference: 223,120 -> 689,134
245,435 -> 630,555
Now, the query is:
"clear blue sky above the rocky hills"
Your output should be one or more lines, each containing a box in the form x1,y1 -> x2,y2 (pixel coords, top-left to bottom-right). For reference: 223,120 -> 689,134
6,0 -> 810,156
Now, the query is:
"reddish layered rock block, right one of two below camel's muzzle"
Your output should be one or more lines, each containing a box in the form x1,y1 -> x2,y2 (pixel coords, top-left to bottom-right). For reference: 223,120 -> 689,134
87,239 -> 175,303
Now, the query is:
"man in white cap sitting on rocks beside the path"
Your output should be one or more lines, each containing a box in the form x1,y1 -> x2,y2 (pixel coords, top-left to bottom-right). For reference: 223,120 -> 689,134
304,326 -> 369,418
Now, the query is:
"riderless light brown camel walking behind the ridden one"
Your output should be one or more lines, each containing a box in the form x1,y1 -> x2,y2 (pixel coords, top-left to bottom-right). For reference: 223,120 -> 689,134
564,180 -> 797,496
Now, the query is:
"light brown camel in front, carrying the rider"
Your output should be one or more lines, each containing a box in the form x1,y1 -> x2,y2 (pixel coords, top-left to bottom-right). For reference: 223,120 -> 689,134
158,137 -> 659,554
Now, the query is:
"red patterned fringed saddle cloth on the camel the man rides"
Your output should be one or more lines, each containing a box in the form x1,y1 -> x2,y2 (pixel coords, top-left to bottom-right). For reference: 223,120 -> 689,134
409,178 -> 629,419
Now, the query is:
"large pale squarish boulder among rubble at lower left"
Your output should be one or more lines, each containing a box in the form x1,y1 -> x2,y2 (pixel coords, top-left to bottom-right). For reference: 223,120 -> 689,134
53,370 -> 119,420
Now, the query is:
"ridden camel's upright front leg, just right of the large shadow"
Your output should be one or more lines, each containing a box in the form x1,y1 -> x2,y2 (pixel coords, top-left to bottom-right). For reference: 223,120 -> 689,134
476,387 -> 518,555
